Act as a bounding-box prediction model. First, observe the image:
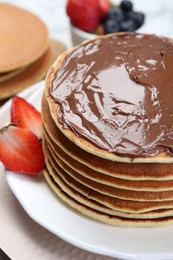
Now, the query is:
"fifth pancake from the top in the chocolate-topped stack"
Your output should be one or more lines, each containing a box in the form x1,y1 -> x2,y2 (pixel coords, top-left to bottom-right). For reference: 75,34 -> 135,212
43,133 -> 172,213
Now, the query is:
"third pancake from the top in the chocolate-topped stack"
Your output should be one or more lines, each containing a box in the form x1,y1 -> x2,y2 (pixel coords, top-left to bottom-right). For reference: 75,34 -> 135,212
43,123 -> 173,191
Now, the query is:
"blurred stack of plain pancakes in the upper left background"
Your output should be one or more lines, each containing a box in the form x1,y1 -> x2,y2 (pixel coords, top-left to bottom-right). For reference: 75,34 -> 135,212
0,3 -> 65,100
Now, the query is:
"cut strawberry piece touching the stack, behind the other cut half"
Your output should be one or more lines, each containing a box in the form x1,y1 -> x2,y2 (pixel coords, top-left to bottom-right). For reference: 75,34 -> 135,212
11,96 -> 42,139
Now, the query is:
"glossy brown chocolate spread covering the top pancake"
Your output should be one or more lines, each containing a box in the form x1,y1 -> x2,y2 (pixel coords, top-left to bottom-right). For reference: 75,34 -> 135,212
49,33 -> 173,157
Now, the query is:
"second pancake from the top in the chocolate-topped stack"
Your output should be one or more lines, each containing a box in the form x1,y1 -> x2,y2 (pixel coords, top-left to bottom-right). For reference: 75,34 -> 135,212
42,93 -> 173,181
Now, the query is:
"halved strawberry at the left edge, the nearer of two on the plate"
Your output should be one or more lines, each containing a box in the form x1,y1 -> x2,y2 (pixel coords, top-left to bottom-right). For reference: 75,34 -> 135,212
0,124 -> 44,174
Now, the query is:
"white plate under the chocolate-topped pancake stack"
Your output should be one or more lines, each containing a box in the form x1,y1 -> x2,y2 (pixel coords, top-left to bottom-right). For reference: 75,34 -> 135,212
0,81 -> 173,260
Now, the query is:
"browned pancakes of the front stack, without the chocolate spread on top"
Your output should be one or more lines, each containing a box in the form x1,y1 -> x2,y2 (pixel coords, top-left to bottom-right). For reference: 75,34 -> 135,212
42,33 -> 173,226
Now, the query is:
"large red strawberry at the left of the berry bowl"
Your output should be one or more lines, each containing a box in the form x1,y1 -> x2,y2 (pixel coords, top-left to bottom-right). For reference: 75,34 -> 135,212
66,0 -> 99,32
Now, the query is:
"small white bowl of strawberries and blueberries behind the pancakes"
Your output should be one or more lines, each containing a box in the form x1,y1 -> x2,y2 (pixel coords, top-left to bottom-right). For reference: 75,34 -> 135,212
66,0 -> 145,45
